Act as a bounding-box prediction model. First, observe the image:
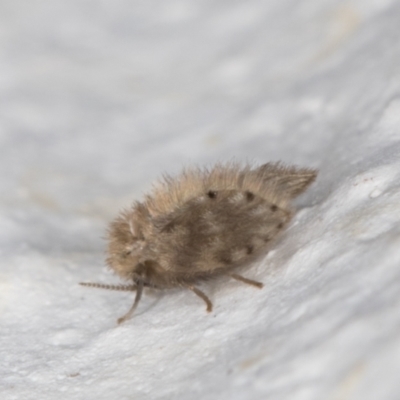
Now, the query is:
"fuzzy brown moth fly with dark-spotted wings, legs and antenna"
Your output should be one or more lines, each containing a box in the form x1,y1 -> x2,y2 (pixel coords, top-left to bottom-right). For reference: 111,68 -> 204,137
83,163 -> 317,322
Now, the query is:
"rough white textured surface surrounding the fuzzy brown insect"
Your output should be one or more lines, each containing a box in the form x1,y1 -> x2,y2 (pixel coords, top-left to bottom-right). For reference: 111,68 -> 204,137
0,0 -> 400,400
